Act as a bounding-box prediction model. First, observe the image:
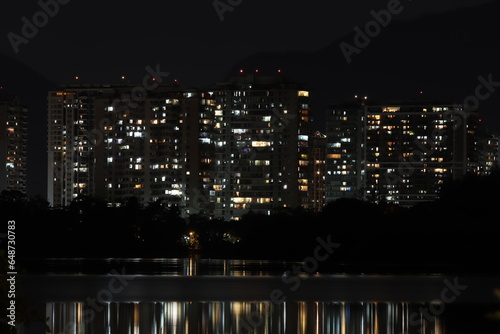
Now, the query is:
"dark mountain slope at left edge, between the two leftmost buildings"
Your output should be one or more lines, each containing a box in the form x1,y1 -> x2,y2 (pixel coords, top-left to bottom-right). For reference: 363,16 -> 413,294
0,54 -> 57,198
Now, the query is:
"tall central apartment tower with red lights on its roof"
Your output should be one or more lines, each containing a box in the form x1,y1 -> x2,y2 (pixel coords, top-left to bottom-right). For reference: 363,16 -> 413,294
212,74 -> 310,219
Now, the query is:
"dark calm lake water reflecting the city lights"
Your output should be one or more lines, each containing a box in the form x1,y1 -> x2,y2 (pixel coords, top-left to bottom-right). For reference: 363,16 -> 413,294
18,258 -> 500,334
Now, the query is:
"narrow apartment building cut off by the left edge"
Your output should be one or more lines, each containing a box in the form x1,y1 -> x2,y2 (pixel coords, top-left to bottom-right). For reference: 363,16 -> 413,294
0,94 -> 28,193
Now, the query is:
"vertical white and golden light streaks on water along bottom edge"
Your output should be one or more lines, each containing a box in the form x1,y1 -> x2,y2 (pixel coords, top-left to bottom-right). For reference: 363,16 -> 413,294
46,301 -> 444,334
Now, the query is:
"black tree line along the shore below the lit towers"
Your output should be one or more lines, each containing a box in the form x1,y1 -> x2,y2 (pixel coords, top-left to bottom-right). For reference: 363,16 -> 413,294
0,173 -> 500,270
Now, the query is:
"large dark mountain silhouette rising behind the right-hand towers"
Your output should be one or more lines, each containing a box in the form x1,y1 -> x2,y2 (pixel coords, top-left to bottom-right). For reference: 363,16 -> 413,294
229,1 -> 500,132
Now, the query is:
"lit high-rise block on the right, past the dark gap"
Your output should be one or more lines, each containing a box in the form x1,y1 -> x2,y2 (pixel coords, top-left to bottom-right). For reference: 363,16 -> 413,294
327,100 -> 482,206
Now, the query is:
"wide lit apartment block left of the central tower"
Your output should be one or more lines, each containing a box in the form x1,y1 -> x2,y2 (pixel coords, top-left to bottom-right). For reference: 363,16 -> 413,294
48,85 -> 214,213
